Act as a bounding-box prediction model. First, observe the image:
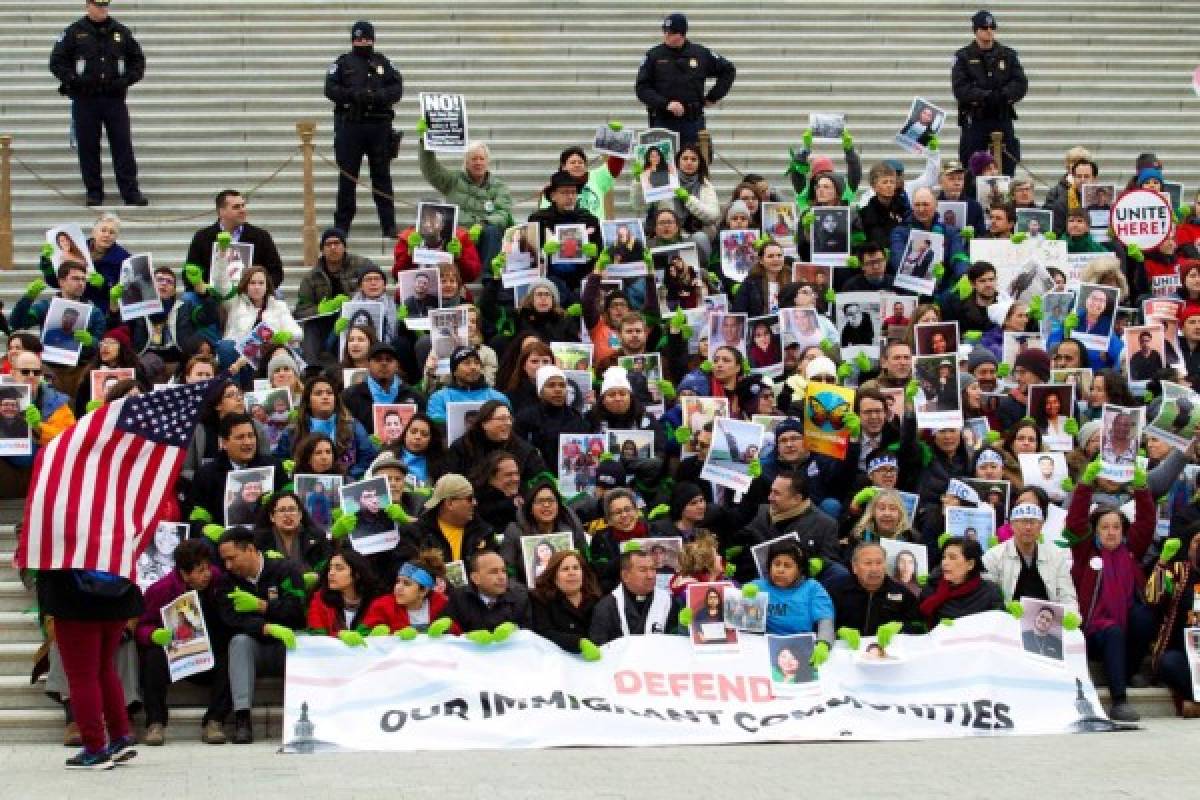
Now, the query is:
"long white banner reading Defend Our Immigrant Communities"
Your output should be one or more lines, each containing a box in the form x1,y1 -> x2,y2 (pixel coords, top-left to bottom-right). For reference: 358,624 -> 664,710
283,612 -> 1114,752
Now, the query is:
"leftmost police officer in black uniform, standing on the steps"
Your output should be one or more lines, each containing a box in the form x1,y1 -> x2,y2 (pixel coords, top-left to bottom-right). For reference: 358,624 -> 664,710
50,0 -> 150,205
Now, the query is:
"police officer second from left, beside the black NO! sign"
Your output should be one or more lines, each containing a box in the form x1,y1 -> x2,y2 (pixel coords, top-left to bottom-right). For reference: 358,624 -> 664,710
325,19 -> 404,239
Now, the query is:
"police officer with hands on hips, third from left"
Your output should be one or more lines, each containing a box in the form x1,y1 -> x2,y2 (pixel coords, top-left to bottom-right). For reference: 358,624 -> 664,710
637,13 -> 737,145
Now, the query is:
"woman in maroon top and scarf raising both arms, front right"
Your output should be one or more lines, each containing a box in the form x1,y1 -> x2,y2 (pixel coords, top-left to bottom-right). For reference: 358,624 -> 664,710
1063,461 -> 1156,722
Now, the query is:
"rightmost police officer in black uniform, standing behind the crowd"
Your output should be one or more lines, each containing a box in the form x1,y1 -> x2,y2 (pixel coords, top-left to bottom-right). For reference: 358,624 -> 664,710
950,11 -> 1030,176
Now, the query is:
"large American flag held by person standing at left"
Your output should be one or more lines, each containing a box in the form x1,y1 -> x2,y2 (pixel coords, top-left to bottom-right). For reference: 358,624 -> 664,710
17,381 -> 211,579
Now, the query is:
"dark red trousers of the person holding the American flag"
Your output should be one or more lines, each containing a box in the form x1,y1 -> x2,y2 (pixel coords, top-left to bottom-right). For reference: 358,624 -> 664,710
54,618 -> 130,753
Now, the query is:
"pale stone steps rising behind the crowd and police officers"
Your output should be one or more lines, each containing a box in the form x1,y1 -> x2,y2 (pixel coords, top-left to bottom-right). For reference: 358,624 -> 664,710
0,0 -> 1200,302
